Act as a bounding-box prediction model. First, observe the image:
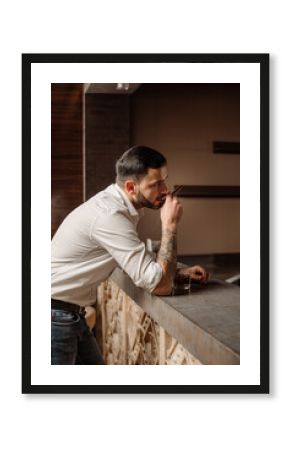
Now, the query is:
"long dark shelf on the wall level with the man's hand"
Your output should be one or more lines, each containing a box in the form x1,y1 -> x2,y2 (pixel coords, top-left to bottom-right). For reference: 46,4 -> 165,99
174,185 -> 240,198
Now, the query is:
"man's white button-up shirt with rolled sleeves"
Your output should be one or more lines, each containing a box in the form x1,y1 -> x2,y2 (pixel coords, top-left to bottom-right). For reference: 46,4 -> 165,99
51,184 -> 162,306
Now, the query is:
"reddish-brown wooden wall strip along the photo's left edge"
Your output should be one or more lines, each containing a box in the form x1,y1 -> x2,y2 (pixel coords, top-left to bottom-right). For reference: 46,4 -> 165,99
51,83 -> 83,236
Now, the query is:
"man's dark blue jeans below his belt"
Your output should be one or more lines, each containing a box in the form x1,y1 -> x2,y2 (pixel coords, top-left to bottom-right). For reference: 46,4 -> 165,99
51,309 -> 104,364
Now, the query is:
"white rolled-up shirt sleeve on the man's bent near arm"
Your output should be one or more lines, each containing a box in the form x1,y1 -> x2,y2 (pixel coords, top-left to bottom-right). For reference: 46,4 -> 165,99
91,211 -> 162,292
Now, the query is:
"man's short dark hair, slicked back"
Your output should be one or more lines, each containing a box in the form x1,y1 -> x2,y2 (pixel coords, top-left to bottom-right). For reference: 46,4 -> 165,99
116,145 -> 167,185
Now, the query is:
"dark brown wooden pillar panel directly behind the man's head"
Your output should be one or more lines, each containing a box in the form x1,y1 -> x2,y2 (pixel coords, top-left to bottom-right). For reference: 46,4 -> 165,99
85,94 -> 130,198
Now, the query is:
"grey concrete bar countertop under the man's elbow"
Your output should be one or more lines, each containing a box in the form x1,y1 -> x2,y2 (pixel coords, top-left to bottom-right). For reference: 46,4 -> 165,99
110,268 -> 240,365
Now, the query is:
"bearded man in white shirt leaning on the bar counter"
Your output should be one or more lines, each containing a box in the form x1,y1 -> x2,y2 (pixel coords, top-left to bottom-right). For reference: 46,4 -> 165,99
51,146 -> 208,364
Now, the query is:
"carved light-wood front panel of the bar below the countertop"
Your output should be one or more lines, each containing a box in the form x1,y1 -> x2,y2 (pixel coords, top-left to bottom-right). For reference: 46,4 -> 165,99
96,280 -> 201,365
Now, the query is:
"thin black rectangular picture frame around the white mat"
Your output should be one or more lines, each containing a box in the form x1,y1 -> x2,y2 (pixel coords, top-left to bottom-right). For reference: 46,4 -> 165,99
22,53 -> 270,394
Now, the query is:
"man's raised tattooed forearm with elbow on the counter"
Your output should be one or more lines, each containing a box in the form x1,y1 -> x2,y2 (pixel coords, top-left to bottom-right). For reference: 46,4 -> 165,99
154,229 -> 177,295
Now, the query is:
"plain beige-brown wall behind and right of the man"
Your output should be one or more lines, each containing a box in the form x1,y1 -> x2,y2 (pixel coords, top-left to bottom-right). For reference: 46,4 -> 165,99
131,84 -> 240,255
